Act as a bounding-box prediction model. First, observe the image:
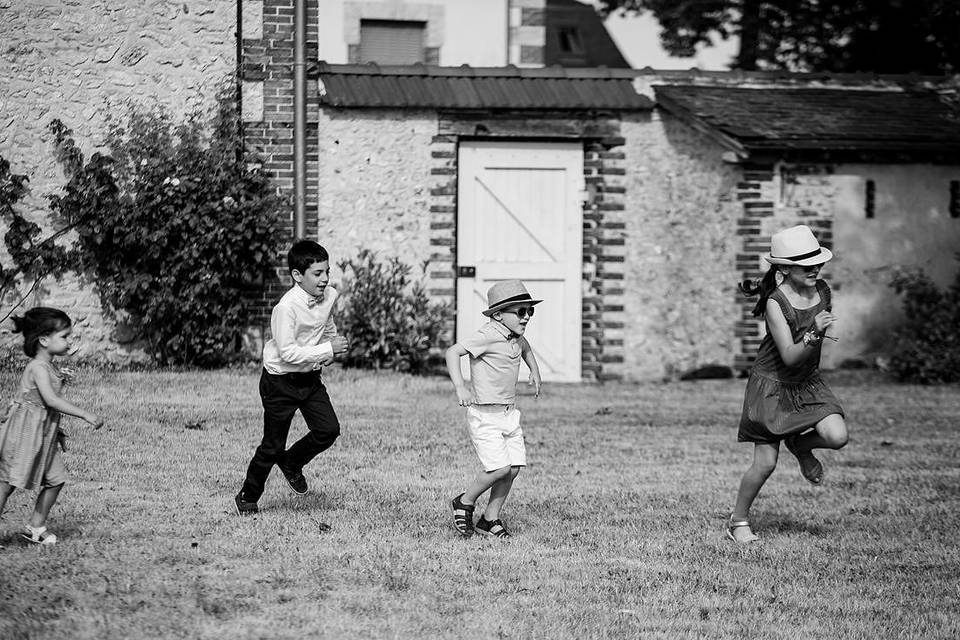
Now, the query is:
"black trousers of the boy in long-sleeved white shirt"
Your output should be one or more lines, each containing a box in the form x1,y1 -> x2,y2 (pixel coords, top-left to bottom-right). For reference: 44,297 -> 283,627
243,369 -> 340,502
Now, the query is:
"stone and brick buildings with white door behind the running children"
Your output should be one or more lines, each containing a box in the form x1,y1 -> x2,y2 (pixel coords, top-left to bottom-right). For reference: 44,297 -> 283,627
0,0 -> 960,380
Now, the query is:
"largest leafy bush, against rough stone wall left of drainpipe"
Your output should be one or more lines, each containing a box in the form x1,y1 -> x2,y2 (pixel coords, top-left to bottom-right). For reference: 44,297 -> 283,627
50,84 -> 282,366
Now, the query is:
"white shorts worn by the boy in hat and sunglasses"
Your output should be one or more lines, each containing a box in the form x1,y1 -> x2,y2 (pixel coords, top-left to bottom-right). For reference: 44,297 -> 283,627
467,405 -> 527,471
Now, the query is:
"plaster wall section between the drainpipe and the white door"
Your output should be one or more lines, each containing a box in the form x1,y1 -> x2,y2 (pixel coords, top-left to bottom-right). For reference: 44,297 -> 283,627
318,109 -> 437,279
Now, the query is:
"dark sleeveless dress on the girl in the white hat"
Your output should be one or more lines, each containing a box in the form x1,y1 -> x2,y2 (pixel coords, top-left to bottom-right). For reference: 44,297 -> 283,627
737,280 -> 843,443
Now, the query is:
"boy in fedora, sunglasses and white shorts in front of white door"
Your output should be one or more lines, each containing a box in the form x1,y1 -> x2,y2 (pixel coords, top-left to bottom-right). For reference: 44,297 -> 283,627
446,280 -> 542,538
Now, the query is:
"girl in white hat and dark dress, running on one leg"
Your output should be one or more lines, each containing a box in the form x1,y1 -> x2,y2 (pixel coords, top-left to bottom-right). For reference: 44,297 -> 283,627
727,225 -> 847,544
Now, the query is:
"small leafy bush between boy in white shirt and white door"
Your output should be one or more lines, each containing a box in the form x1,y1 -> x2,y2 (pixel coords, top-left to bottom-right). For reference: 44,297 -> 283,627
337,249 -> 452,374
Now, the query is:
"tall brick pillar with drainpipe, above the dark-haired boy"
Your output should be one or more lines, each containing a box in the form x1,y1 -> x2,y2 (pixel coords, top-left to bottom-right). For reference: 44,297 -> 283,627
241,0 -> 322,324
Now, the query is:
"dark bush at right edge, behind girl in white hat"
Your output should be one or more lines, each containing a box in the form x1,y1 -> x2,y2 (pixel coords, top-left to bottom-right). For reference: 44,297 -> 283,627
890,254 -> 960,384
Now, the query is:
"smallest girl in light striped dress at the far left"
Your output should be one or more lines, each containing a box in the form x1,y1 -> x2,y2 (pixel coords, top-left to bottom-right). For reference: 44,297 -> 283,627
0,307 -> 103,545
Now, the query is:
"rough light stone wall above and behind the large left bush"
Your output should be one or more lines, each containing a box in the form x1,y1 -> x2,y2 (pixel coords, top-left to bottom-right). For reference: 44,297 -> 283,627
0,0 -> 236,360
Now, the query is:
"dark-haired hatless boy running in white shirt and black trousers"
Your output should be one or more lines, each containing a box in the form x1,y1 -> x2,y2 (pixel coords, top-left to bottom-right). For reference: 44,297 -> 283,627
234,240 -> 348,515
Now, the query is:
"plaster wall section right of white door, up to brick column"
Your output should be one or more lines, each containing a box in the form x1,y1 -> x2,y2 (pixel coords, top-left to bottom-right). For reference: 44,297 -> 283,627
622,111 -> 742,380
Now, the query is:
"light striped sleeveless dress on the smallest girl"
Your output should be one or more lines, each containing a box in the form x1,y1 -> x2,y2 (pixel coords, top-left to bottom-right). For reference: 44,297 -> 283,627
0,363 -> 67,489
